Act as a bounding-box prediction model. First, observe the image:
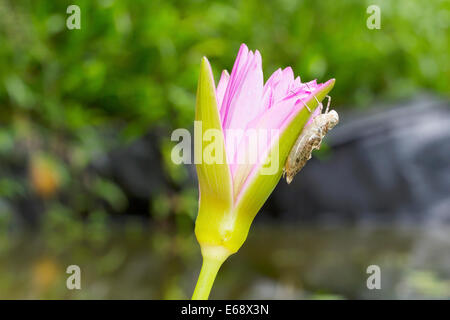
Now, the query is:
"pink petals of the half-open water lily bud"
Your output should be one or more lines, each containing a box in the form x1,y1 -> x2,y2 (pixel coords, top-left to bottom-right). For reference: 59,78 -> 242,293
216,44 -> 334,200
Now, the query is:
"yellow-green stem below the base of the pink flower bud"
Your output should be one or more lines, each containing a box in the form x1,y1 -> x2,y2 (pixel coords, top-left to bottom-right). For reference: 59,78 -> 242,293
192,247 -> 229,300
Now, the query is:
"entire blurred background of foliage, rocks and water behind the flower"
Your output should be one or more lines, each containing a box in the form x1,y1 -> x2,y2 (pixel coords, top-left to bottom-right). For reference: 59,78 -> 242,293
0,0 -> 450,299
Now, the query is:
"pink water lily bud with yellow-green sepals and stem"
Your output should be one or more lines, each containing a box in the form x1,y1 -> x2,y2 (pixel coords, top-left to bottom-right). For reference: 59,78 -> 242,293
193,44 -> 335,299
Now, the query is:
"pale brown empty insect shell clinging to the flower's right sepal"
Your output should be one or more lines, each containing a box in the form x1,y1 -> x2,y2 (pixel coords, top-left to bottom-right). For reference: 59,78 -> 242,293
283,84 -> 339,184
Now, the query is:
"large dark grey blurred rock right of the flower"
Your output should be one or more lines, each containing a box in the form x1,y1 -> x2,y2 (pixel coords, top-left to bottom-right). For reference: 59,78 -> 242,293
261,97 -> 450,224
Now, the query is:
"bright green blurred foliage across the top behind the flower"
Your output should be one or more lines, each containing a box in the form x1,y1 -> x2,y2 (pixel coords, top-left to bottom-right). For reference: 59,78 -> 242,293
0,0 -> 450,220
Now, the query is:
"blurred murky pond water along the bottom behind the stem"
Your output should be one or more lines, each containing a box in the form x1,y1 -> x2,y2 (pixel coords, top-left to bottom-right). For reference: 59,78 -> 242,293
0,225 -> 450,299
